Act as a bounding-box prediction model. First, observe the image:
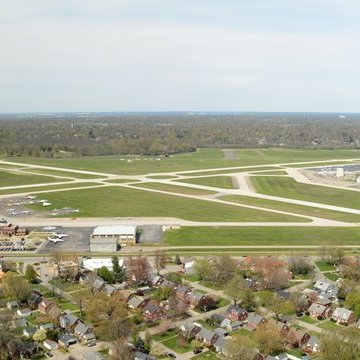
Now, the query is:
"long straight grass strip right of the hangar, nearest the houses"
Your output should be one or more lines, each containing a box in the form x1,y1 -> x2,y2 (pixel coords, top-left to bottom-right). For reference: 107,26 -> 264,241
164,226 -> 360,247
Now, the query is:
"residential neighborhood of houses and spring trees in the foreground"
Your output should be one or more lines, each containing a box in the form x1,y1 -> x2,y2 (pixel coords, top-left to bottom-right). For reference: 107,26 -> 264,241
0,253 -> 360,360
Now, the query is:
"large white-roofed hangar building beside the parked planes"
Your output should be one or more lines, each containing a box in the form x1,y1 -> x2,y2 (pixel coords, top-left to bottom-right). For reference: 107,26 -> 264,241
90,225 -> 137,252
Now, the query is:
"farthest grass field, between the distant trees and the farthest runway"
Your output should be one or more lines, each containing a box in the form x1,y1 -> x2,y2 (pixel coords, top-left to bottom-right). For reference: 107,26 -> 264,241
7,148 -> 360,175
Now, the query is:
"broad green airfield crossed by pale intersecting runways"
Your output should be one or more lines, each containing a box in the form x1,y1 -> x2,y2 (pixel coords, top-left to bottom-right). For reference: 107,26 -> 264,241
0,149 -> 360,253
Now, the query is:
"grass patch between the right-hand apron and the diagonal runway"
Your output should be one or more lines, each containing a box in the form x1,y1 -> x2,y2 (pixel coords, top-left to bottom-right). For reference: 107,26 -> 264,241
250,176 -> 360,209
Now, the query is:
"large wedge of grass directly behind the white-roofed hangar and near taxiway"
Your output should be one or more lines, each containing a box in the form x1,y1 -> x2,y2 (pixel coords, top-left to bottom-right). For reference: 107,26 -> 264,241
25,186 -> 307,222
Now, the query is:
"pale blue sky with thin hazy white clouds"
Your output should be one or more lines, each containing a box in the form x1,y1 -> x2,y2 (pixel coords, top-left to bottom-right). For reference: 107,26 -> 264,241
0,0 -> 360,113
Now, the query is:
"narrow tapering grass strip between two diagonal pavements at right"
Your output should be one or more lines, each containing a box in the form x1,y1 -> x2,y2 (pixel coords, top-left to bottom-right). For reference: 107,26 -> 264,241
219,195 -> 360,223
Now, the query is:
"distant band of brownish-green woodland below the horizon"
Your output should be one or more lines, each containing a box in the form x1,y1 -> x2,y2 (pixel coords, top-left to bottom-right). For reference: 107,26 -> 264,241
0,113 -> 360,157
